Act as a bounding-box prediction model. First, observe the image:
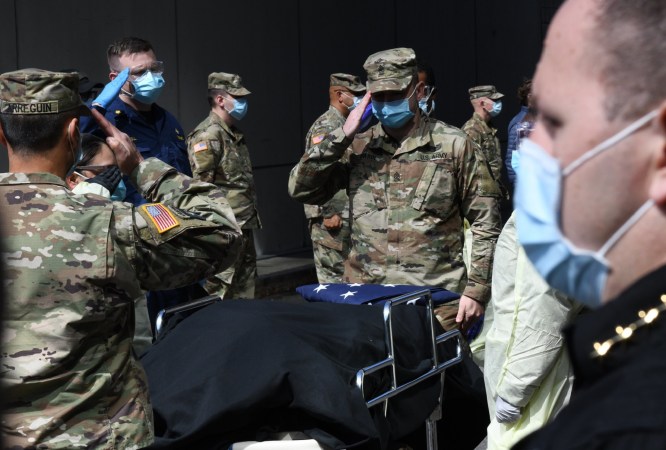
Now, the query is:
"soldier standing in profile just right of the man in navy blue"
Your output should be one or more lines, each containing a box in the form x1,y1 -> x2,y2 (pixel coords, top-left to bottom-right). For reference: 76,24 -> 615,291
187,72 -> 261,298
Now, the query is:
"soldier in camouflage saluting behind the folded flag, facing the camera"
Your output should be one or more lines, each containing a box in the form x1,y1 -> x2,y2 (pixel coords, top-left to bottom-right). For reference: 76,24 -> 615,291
289,48 -> 500,329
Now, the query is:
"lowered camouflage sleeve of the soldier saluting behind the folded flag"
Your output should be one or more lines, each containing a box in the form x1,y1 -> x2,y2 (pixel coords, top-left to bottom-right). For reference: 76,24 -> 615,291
455,134 -> 501,304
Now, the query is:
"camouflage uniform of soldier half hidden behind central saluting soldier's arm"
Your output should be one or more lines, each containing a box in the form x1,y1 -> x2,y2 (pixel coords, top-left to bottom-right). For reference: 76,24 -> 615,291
305,106 -> 351,283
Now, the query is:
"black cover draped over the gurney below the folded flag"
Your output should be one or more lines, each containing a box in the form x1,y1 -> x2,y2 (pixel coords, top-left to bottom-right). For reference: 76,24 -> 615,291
142,300 -> 455,449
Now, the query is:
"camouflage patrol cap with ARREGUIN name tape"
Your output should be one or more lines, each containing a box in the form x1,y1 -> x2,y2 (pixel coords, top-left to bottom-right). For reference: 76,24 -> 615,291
0,69 -> 90,115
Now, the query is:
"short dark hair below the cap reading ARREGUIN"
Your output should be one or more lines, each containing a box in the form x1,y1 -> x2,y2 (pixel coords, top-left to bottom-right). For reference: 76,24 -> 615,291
0,110 -> 78,156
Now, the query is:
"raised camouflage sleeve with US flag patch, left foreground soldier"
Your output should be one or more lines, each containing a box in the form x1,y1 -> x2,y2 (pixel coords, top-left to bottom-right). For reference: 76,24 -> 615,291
111,158 -> 242,290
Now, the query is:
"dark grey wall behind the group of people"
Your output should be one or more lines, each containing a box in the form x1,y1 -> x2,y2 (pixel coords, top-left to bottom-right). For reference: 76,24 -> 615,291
0,0 -> 561,255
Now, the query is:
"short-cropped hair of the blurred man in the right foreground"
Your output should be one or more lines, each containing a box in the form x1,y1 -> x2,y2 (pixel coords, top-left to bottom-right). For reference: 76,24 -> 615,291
588,0 -> 666,120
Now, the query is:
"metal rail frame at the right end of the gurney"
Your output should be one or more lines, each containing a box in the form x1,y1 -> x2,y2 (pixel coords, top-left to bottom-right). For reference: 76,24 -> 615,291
356,289 -> 462,450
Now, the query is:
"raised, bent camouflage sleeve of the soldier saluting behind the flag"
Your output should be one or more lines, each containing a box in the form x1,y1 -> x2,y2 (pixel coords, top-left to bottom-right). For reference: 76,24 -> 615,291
288,127 -> 352,205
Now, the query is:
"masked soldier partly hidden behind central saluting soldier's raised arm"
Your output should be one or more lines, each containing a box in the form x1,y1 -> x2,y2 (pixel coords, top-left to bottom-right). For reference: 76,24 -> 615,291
305,73 -> 365,283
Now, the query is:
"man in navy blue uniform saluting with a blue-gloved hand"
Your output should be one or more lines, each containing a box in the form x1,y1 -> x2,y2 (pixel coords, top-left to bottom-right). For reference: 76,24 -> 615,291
81,37 -> 207,338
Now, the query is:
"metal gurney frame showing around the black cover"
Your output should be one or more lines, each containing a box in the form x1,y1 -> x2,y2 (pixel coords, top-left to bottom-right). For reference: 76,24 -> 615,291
148,290 -> 462,450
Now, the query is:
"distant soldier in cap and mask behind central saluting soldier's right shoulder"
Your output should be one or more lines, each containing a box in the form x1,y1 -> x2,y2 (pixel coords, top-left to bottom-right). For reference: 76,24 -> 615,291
462,85 -> 504,189
